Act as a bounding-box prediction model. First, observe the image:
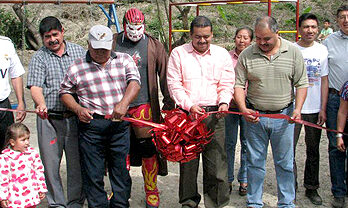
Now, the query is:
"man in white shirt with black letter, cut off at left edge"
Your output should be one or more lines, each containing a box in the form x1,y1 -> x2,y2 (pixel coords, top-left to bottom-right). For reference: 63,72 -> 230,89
0,36 -> 26,148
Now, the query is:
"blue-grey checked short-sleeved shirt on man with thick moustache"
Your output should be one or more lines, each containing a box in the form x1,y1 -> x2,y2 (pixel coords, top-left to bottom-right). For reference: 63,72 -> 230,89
27,41 -> 86,111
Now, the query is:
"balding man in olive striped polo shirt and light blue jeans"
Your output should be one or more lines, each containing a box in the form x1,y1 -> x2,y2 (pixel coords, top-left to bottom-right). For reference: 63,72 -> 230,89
235,16 -> 308,207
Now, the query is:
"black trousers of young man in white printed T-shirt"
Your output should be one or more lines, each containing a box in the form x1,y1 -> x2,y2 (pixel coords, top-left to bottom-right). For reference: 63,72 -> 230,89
294,113 -> 321,189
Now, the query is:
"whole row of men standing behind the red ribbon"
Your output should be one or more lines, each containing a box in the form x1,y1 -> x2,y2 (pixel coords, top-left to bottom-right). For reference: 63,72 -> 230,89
1,5 -> 348,208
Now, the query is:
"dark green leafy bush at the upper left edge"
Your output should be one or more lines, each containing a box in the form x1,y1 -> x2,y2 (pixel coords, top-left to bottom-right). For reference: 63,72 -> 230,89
0,8 -> 22,48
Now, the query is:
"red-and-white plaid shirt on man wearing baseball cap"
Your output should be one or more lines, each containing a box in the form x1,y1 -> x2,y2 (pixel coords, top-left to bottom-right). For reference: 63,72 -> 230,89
59,52 -> 140,115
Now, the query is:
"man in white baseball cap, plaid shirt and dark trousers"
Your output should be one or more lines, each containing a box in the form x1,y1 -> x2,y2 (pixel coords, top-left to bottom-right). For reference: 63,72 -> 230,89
59,25 -> 140,207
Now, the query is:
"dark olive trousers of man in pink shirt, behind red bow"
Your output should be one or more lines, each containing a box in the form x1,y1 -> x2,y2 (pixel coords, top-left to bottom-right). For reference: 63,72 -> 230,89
179,114 -> 229,208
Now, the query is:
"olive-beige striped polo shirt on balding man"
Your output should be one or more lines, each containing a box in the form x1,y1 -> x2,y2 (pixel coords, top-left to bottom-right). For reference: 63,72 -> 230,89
235,38 -> 308,111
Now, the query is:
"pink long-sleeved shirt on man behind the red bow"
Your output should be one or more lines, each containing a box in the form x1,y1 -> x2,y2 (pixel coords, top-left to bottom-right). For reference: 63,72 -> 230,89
167,43 -> 235,111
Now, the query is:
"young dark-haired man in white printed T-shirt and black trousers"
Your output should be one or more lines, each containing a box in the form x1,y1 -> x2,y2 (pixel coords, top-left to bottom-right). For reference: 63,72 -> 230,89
294,13 -> 329,205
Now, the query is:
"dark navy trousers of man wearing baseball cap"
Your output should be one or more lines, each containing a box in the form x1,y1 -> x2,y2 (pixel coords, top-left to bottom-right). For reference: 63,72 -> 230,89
79,119 -> 132,208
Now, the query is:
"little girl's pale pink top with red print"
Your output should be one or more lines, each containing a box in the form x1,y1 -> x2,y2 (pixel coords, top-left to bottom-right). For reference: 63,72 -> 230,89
0,147 -> 47,208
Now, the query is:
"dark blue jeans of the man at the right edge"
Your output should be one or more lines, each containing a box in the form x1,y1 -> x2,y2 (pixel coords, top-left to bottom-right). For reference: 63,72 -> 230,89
326,93 -> 347,197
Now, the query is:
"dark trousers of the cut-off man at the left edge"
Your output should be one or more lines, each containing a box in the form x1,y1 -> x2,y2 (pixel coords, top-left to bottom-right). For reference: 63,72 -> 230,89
0,98 -> 14,149
